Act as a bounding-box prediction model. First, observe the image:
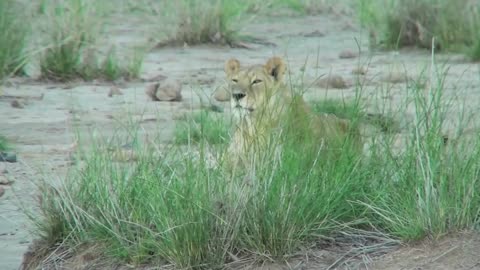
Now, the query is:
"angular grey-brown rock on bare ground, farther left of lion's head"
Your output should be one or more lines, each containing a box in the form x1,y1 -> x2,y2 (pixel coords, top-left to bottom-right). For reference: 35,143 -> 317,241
145,80 -> 182,101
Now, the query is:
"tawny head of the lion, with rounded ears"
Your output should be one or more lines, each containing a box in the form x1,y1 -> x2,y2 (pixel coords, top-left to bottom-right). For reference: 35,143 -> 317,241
225,57 -> 286,117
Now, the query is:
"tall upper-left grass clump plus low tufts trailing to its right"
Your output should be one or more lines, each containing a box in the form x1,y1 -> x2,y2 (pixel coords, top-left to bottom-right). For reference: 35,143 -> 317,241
40,0 -> 143,81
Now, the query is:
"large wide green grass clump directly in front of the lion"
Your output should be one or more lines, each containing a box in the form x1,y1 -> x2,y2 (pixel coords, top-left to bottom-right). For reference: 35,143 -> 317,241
31,89 -> 367,269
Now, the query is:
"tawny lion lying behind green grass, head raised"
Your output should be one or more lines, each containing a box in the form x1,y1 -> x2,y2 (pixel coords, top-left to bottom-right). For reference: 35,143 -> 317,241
225,57 -> 362,169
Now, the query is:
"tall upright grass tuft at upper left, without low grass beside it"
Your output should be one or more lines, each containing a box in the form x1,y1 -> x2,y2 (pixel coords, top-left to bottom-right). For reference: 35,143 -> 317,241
40,0 -> 101,81
